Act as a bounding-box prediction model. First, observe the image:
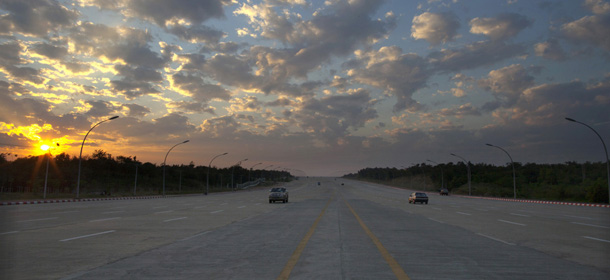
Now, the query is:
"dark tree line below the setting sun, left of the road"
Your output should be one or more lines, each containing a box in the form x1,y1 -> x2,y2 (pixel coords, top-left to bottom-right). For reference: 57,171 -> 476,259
0,150 -> 292,197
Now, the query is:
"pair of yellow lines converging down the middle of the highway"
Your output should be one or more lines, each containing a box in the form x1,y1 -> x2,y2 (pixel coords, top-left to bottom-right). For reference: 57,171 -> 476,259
277,197 -> 410,280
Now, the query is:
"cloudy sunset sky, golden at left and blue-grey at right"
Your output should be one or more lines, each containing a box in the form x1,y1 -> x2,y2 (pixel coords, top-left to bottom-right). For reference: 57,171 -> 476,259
0,0 -> 610,176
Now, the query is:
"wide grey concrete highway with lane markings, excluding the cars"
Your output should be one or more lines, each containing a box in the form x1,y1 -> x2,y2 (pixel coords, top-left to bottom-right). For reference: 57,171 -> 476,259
0,178 -> 610,279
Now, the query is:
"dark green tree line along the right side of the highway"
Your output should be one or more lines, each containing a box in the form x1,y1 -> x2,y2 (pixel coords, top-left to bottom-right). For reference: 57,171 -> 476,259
345,162 -> 608,203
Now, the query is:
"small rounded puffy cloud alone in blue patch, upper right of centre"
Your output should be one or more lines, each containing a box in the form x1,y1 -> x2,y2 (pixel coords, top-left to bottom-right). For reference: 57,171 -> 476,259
411,12 -> 460,45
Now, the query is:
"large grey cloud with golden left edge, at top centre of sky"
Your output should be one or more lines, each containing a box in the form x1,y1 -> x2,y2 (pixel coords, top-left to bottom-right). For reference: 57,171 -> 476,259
235,0 -> 396,78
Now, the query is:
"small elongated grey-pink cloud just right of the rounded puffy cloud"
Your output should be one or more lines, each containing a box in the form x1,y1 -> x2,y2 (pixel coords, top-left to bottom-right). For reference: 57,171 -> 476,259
470,13 -> 532,40
